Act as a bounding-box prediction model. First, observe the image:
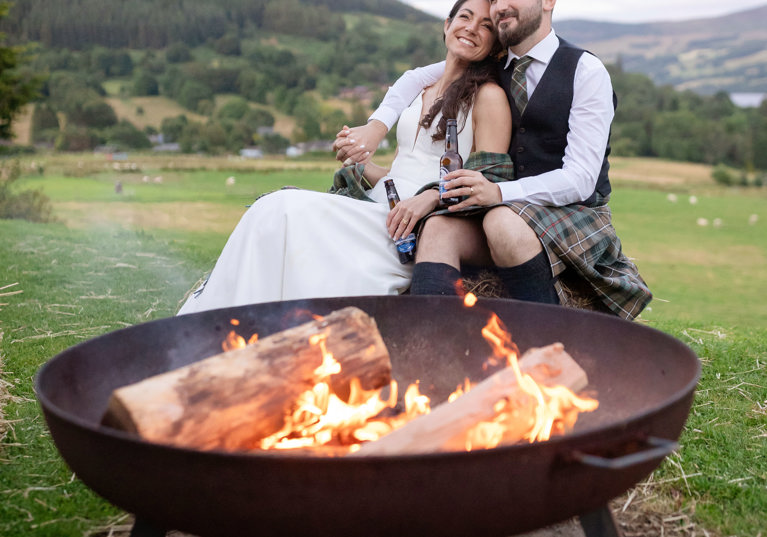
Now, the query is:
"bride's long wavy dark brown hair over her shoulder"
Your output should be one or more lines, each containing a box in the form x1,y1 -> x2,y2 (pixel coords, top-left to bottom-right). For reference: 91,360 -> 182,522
421,0 -> 503,141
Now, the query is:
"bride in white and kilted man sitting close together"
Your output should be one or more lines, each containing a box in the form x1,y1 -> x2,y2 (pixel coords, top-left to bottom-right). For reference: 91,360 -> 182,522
179,0 -> 652,319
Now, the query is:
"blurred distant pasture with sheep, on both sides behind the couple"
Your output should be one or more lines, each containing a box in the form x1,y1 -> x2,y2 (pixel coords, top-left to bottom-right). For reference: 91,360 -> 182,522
12,150 -> 767,325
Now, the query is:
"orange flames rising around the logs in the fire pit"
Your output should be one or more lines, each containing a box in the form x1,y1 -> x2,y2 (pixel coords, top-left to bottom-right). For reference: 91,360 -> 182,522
246,310 -> 599,453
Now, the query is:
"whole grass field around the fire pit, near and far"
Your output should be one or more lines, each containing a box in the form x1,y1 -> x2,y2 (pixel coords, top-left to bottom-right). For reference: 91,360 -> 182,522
0,155 -> 767,537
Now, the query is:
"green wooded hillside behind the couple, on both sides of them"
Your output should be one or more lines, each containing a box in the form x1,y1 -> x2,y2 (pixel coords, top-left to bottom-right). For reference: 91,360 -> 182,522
0,0 -> 767,177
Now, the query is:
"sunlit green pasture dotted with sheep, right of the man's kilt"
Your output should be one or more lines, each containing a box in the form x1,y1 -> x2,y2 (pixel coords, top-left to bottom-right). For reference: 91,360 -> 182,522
610,189 -> 767,327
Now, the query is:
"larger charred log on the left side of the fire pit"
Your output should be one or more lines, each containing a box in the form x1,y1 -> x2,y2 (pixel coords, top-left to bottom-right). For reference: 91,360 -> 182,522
102,307 -> 391,450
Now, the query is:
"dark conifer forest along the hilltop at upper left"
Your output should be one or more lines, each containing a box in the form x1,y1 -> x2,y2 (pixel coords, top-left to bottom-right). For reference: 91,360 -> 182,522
0,0 -> 435,50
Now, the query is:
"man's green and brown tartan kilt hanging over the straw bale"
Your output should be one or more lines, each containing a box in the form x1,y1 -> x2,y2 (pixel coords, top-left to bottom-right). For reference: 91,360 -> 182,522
503,201 -> 652,319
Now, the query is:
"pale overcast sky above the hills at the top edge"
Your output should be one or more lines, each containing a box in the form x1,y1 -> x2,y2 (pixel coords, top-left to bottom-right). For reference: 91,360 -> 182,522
402,0 -> 767,24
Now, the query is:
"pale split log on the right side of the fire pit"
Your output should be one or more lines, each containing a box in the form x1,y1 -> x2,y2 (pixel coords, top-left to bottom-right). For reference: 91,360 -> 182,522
351,343 -> 588,456
